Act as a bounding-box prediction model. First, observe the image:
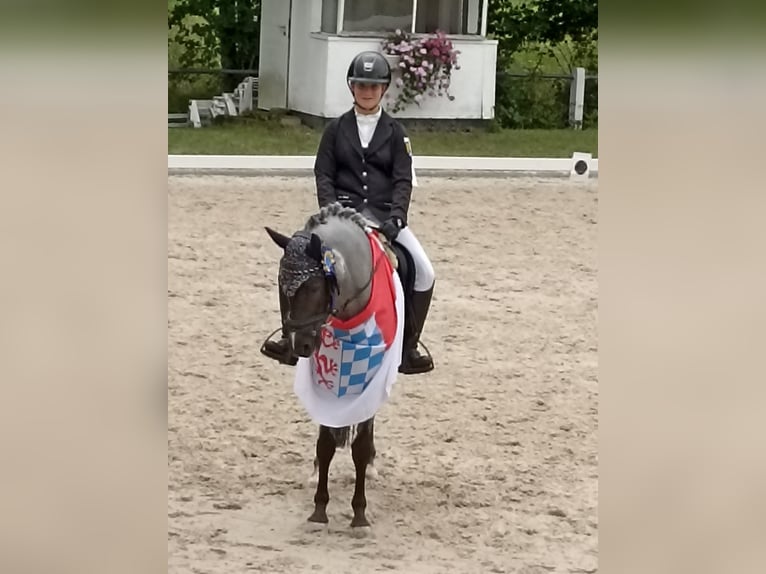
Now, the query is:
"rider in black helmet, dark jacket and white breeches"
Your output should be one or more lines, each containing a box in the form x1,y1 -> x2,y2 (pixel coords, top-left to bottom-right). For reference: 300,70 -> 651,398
269,48 -> 434,374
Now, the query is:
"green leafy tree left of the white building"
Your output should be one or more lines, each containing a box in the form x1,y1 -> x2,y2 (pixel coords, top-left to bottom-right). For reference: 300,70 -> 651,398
168,0 -> 261,89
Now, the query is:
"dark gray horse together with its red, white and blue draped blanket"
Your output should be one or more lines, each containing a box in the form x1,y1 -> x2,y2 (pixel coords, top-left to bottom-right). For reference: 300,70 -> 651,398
264,203 -> 412,527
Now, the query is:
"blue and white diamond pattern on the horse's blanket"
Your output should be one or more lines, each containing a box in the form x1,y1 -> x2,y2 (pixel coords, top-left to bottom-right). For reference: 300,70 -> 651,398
335,315 -> 386,397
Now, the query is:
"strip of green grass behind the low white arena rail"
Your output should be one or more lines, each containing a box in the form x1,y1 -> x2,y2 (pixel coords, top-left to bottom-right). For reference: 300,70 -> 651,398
168,116 -> 598,157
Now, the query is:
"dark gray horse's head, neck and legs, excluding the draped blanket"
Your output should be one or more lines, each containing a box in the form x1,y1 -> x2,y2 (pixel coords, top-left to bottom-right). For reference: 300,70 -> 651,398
266,204 -> 396,526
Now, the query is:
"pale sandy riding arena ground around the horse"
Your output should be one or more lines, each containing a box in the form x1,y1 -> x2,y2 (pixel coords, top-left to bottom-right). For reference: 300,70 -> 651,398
168,176 -> 598,574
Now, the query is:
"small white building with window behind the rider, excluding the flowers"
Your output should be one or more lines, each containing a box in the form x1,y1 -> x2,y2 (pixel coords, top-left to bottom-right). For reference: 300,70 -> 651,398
258,0 -> 497,120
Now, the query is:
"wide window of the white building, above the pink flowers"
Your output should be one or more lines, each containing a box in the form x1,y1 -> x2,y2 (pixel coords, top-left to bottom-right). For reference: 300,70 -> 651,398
322,0 -> 488,35
